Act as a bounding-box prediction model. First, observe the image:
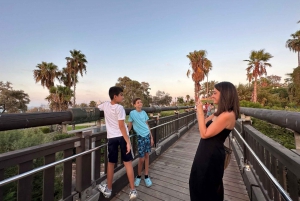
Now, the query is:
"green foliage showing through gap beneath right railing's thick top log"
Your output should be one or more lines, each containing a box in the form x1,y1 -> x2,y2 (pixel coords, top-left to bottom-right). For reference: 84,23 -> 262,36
252,118 -> 295,149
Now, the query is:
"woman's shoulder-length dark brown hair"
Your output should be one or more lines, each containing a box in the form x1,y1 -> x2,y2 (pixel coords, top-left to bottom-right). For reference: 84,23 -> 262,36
214,82 -> 240,119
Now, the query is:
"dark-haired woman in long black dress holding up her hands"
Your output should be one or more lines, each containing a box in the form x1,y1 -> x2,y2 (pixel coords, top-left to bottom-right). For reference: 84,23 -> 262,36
189,82 -> 240,201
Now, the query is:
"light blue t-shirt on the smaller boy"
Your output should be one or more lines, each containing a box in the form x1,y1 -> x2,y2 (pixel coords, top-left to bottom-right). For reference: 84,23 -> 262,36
128,110 -> 150,137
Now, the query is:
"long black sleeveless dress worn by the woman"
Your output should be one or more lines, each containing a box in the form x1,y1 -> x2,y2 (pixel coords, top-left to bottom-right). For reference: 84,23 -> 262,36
189,120 -> 231,201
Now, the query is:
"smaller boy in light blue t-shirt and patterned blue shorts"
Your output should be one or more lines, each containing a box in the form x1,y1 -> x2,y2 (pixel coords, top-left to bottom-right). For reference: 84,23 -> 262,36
128,98 -> 154,187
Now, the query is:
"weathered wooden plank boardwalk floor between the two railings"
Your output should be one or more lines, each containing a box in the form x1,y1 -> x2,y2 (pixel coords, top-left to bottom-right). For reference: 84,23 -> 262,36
112,124 -> 249,201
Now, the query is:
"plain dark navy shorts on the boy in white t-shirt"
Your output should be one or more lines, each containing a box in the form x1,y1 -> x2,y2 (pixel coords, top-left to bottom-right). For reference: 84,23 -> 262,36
107,136 -> 134,163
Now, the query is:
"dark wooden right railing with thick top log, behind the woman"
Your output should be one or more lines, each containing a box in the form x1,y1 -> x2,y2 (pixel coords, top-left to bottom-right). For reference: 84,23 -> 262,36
232,108 -> 300,201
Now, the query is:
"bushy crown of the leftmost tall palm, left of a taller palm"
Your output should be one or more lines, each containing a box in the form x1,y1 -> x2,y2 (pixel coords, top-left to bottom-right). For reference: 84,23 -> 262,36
33,61 -> 60,89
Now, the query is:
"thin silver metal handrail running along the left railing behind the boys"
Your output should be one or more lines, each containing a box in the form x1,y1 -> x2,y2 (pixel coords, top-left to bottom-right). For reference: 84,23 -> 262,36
0,113 -> 194,187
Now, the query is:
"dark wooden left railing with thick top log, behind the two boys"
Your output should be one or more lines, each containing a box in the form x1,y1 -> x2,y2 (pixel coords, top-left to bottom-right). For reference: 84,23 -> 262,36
0,107 -> 196,201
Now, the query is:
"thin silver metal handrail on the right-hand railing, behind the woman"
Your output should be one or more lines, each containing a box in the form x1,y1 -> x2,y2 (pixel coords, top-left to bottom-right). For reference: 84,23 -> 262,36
234,128 -> 293,201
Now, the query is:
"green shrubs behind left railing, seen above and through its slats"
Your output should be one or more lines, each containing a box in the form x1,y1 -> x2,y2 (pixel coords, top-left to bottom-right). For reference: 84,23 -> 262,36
0,127 -> 74,201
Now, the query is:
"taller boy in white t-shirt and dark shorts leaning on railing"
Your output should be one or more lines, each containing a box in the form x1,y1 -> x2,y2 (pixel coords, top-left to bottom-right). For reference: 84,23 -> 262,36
98,87 -> 137,200
